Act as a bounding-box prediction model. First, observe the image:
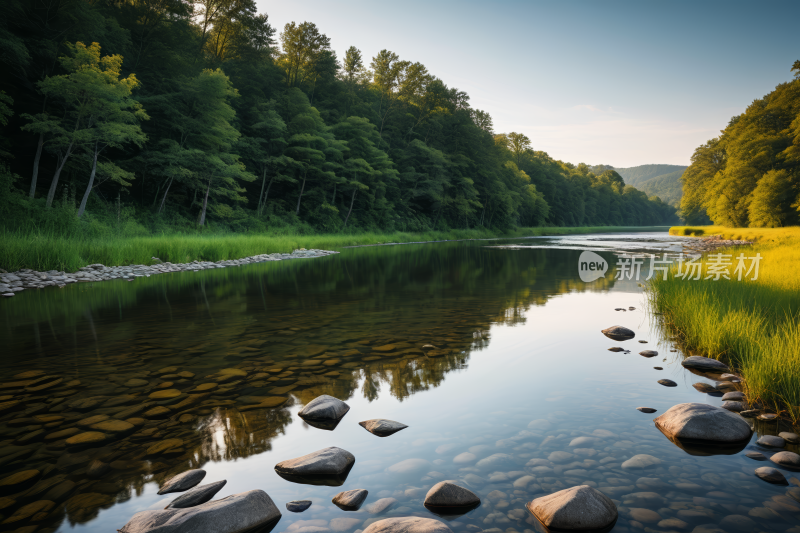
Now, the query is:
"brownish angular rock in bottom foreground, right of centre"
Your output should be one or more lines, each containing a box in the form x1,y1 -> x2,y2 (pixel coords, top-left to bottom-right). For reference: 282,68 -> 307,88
527,485 -> 618,531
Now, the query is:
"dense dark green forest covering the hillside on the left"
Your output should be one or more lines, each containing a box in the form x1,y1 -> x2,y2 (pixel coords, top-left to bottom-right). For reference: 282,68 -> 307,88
0,0 -> 677,235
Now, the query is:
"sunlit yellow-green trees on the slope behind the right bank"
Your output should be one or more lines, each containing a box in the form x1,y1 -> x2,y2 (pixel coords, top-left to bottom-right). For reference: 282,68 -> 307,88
681,61 -> 800,228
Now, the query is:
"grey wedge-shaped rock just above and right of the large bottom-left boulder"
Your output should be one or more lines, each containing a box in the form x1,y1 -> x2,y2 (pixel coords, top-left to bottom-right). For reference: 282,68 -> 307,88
275,446 -> 356,487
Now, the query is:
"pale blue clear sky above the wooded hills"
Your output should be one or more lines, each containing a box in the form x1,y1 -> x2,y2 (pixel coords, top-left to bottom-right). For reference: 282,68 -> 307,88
258,0 -> 800,167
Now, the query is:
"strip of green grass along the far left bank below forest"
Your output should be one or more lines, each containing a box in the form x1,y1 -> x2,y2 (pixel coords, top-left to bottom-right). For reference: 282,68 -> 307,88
0,227 -> 654,272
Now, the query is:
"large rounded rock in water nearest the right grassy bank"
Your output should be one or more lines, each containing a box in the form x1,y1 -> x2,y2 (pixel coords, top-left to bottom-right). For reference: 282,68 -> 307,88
655,403 -> 752,443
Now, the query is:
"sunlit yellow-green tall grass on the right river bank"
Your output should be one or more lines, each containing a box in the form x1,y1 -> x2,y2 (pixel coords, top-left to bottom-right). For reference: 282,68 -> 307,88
649,226 -> 800,424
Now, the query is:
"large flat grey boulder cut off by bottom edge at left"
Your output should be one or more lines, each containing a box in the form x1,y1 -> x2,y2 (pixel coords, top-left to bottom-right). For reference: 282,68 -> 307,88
119,490 -> 281,533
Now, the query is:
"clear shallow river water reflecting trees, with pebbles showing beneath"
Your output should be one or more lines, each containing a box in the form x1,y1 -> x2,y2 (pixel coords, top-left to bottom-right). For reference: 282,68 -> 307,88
0,233 -> 800,533
